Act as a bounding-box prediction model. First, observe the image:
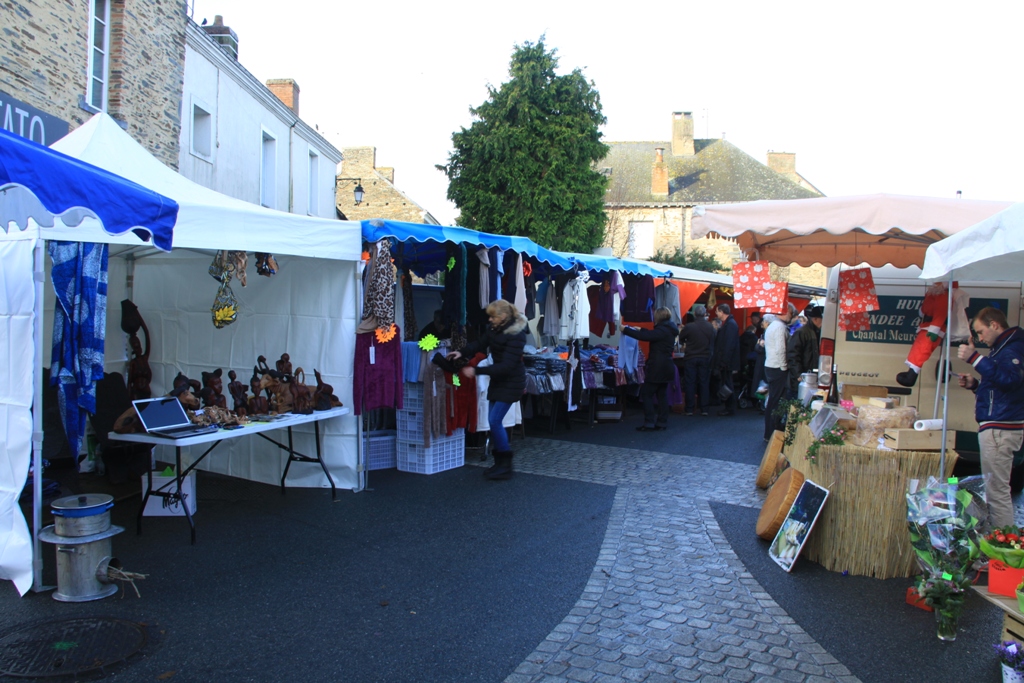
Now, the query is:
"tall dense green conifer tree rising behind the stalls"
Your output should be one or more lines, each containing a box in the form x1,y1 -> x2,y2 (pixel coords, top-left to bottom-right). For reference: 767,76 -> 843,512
437,36 -> 608,253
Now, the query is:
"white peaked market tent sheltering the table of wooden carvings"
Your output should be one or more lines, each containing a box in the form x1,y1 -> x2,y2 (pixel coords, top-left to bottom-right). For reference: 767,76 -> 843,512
0,114 -> 362,584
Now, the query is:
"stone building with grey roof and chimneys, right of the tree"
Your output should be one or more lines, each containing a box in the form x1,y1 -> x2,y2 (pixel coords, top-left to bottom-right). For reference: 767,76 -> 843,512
596,112 -> 824,286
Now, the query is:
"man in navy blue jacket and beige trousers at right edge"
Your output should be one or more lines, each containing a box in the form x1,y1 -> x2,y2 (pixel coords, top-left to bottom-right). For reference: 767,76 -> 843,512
956,306 -> 1024,528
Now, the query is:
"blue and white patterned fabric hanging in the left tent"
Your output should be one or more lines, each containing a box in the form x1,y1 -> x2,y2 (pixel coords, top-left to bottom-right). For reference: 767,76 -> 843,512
47,242 -> 108,464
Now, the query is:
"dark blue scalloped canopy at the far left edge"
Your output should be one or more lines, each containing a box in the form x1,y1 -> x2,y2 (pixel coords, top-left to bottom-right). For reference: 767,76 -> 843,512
0,124 -> 178,251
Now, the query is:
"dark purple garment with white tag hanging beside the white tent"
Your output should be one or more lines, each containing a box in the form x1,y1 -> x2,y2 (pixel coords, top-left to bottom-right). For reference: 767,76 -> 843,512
352,330 -> 402,415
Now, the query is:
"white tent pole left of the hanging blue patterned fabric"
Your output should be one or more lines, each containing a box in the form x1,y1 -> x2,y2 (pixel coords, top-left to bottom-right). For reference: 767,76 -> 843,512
32,239 -> 47,593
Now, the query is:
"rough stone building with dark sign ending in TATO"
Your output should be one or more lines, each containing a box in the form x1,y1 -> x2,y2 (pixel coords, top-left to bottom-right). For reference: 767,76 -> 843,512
0,0 -> 187,169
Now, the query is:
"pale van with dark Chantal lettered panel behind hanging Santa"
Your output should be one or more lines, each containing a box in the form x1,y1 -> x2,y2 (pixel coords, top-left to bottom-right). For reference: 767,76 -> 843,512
818,266 -> 1024,490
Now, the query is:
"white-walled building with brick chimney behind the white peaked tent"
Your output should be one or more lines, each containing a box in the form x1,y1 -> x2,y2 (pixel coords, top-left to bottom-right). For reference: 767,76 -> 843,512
178,15 -> 341,218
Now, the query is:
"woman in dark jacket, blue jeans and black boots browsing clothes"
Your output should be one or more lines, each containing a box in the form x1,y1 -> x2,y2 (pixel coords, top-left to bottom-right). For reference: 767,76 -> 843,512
447,299 -> 526,479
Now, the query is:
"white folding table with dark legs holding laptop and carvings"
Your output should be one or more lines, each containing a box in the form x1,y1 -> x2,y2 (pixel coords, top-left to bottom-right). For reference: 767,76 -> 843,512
108,408 -> 349,544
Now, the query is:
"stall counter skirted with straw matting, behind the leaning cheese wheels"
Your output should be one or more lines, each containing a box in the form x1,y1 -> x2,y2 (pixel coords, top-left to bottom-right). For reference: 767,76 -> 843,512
782,424 -> 956,579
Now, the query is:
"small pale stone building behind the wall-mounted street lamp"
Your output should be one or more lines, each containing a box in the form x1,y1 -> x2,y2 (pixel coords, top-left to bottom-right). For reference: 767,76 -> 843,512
335,147 -> 439,225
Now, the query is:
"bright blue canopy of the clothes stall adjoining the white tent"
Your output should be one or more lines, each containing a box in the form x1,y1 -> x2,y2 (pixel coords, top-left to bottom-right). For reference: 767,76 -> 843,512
362,219 -> 573,275
